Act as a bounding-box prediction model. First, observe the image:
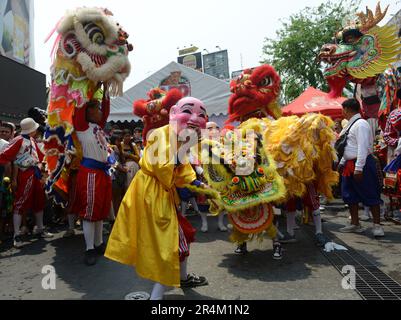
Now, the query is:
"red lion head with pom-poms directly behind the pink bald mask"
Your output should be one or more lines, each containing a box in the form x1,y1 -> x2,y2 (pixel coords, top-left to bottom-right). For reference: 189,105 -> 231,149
134,88 -> 183,143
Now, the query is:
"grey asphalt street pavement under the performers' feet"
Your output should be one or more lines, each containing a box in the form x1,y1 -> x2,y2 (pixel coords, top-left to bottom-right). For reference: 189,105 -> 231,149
0,204 -> 401,300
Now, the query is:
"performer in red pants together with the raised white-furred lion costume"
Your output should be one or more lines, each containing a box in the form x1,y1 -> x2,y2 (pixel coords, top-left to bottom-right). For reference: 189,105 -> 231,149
45,7 -> 132,262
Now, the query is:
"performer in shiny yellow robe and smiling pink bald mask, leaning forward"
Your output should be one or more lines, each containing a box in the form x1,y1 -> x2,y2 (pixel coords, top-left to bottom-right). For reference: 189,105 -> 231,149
105,97 -> 207,300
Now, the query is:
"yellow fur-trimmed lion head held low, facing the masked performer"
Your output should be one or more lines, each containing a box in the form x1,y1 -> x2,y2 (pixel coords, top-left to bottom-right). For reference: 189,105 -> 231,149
202,128 -> 286,242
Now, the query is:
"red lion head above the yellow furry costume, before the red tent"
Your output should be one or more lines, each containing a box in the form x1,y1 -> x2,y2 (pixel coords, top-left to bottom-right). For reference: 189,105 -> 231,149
227,64 -> 281,124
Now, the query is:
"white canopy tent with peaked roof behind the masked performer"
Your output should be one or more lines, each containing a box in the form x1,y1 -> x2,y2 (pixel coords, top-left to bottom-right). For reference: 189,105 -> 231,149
109,62 -> 230,126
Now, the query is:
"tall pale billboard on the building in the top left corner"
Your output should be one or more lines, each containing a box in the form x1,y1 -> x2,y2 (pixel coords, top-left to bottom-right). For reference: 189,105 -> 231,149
0,0 -> 34,67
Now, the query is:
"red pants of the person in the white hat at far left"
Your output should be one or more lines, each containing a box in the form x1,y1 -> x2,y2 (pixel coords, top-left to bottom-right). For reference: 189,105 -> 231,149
14,168 -> 46,214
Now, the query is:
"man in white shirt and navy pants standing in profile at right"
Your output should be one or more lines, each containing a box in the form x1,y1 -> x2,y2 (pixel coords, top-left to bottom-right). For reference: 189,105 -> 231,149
339,99 -> 384,237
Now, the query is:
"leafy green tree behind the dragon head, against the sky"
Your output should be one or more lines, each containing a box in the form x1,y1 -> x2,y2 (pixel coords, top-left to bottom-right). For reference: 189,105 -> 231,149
262,0 -> 360,104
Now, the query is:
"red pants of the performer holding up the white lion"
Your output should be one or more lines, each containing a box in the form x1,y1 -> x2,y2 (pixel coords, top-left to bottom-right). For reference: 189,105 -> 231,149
72,166 -> 112,222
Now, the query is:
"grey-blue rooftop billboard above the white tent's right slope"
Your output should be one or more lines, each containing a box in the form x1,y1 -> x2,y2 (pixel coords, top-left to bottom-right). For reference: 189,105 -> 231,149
203,50 -> 230,80
